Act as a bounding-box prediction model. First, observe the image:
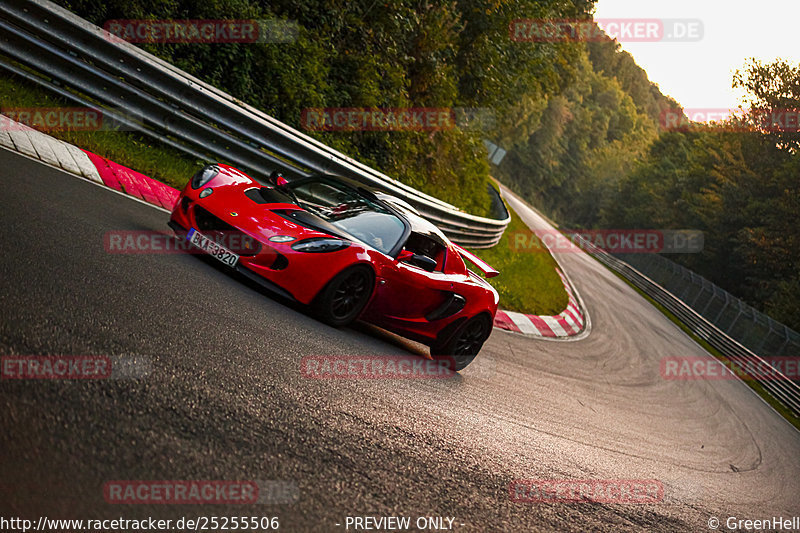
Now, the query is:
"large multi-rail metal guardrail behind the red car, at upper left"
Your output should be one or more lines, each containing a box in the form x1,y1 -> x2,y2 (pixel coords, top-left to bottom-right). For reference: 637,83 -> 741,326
0,0 -> 510,248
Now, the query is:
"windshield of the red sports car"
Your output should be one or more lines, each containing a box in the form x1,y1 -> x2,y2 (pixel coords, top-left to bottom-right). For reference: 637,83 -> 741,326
288,179 -> 405,254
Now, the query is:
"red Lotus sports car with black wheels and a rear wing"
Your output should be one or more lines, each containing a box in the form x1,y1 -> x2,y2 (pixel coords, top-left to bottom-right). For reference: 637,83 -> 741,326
169,164 -> 498,370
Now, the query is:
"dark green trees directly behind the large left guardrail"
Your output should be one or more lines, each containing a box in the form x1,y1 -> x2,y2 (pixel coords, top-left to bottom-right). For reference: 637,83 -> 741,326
56,0 -> 593,214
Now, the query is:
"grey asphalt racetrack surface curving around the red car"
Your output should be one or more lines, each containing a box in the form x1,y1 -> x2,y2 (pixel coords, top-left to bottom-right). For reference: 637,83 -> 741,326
0,150 -> 800,532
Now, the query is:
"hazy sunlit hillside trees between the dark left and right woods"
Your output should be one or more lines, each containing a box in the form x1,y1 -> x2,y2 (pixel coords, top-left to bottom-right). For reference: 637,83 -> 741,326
498,32 -> 679,226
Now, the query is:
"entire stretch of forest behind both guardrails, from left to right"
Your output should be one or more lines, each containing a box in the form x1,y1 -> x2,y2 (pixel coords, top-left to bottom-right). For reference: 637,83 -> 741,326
54,0 -> 800,329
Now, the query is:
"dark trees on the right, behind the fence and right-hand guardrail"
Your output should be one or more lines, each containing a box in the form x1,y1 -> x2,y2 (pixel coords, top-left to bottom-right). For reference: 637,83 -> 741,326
608,60 -> 800,329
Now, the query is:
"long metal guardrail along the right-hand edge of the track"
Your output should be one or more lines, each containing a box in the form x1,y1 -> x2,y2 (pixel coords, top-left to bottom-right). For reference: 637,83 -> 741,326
576,236 -> 800,416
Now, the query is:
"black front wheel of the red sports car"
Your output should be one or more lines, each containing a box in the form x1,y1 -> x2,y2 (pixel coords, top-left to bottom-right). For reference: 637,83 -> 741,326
312,265 -> 375,328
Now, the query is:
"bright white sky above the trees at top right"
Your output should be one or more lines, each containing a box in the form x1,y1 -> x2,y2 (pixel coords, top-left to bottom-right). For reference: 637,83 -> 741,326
595,0 -> 800,117
